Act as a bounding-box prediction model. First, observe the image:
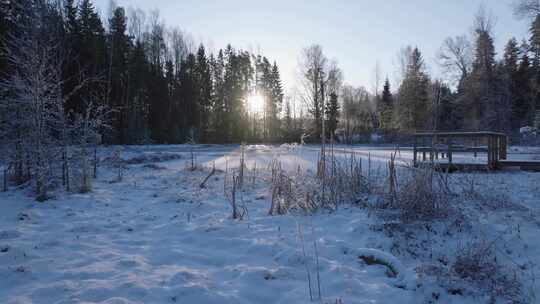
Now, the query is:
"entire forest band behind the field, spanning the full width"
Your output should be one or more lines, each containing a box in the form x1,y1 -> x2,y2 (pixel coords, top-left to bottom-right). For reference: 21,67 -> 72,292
0,0 -> 540,148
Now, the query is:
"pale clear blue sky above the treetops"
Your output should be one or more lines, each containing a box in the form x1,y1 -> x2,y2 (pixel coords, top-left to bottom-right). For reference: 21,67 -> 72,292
94,0 -> 529,89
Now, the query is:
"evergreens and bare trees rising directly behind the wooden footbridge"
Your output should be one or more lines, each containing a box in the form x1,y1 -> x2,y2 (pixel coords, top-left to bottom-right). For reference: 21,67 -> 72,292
373,9 -> 540,138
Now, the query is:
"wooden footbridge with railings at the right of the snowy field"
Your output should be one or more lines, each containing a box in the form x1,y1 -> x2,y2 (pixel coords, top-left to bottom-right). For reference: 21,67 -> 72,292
413,132 -> 540,172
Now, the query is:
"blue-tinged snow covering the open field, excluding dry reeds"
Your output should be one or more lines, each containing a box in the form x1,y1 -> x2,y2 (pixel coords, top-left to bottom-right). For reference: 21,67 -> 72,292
0,145 -> 540,304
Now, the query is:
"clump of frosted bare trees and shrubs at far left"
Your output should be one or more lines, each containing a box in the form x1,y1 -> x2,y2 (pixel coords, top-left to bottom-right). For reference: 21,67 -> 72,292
0,0 -> 108,200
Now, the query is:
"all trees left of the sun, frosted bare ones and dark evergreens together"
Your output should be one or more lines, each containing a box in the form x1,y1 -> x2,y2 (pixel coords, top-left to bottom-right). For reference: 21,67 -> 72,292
0,0 -> 288,199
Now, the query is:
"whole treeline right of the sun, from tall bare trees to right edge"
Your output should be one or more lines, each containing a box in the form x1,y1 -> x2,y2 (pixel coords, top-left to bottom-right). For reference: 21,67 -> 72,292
300,0 -> 540,143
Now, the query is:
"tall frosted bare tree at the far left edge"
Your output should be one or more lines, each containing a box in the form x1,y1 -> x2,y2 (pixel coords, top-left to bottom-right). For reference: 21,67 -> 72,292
0,26 -> 64,199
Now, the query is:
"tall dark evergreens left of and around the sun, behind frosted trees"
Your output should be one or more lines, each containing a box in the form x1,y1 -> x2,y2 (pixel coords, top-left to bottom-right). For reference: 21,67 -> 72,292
0,0 -> 283,144
